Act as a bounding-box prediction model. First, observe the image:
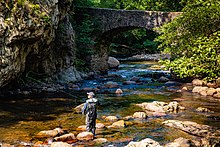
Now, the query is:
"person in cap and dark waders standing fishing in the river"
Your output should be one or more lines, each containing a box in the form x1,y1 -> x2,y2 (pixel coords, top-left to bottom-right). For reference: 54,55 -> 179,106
82,92 -> 99,137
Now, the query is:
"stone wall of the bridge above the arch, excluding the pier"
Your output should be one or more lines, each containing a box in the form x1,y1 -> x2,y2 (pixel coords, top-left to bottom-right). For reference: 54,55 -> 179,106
76,8 -> 182,32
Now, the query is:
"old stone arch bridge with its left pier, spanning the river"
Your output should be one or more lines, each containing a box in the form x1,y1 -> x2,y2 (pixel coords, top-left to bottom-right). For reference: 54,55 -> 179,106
76,8 -> 181,71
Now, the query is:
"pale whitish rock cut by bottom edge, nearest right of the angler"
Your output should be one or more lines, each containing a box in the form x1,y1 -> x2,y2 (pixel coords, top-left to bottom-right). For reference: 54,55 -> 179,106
125,138 -> 162,147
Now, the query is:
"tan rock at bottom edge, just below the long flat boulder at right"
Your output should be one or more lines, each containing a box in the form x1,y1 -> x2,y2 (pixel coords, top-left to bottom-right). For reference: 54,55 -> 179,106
164,137 -> 196,147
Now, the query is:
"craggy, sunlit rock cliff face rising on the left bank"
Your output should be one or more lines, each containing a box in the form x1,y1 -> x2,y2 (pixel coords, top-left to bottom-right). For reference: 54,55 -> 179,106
0,0 -> 75,88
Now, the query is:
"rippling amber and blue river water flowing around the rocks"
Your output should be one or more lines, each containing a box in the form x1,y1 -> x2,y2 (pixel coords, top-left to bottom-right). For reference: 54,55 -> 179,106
0,62 -> 220,146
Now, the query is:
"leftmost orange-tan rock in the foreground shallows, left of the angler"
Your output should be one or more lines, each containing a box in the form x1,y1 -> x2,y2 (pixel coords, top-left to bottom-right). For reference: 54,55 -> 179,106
36,128 -> 64,138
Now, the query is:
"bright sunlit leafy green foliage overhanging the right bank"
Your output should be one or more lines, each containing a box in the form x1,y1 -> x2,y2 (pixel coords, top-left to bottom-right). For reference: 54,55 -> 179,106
157,0 -> 220,81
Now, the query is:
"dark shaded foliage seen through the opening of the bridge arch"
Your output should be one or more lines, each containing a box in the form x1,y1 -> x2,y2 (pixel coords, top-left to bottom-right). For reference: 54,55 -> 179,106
110,29 -> 159,56
